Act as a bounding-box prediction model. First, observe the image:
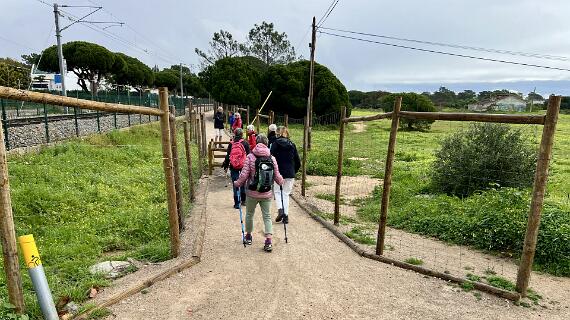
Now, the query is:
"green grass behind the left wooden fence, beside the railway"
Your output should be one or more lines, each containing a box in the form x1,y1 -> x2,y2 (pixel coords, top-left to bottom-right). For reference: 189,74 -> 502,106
0,124 -> 198,319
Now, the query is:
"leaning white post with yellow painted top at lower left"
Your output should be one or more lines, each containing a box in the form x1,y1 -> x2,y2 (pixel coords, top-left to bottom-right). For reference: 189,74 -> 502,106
18,234 -> 59,320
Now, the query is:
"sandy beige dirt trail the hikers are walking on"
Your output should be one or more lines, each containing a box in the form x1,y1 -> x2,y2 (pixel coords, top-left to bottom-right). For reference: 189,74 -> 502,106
108,111 -> 569,319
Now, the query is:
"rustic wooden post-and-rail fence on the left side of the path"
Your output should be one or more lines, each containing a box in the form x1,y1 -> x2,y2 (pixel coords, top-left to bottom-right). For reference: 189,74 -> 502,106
0,87 -> 202,312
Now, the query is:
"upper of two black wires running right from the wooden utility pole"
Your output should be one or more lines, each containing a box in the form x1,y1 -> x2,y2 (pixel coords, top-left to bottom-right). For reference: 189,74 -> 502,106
319,26 -> 570,61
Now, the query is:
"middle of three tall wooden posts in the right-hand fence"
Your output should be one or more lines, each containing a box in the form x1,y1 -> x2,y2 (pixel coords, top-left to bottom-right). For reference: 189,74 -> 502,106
376,97 -> 402,255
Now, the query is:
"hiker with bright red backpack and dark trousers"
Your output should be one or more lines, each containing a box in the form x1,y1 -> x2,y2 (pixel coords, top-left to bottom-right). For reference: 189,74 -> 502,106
222,128 -> 250,209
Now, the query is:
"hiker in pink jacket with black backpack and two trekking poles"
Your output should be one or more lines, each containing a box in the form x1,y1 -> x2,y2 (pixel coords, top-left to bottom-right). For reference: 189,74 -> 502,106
234,134 -> 283,252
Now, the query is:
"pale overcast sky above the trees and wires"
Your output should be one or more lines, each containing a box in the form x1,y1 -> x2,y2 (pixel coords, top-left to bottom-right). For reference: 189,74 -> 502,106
0,0 -> 570,95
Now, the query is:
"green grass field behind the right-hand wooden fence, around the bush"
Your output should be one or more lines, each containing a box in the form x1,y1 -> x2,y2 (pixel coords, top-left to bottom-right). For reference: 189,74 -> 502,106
286,110 -> 570,276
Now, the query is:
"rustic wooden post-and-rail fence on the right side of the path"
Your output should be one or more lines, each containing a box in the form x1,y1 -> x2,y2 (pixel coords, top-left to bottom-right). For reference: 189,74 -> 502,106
324,96 -> 561,299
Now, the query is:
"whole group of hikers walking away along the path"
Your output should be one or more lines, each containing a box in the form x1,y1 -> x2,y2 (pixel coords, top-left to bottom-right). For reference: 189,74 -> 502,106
214,108 -> 301,252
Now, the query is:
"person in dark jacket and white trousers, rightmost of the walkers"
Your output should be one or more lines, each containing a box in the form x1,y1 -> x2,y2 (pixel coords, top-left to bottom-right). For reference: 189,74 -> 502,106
271,126 -> 301,224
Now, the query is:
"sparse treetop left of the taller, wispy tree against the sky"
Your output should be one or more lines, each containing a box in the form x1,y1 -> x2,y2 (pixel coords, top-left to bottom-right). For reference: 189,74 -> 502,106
194,30 -> 244,68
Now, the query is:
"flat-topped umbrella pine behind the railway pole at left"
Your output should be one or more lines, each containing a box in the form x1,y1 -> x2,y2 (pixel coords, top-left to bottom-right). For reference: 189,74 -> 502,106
39,41 -> 127,92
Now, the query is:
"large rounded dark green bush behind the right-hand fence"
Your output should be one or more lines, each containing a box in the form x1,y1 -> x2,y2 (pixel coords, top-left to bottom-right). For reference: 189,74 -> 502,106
431,123 -> 537,197
